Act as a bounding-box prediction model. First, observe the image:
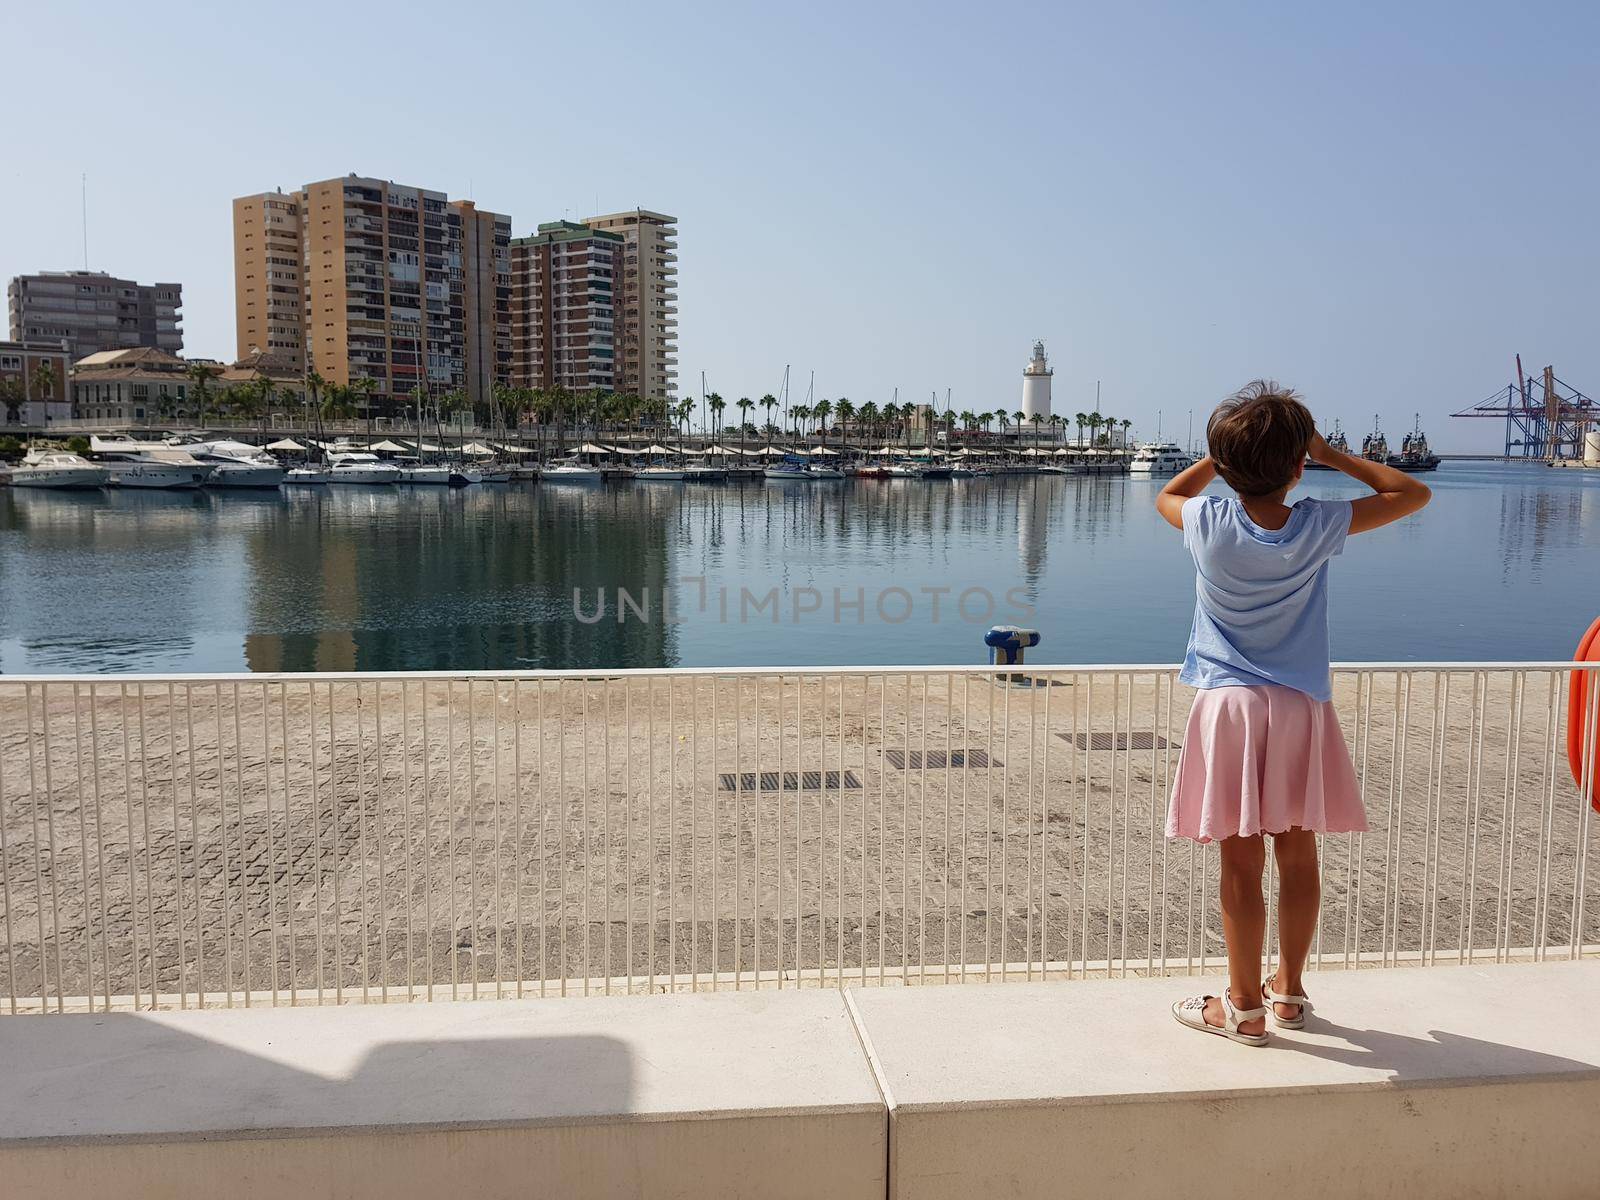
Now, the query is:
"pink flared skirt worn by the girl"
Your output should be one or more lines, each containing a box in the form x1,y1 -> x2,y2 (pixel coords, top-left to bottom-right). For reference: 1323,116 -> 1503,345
1166,685 -> 1366,842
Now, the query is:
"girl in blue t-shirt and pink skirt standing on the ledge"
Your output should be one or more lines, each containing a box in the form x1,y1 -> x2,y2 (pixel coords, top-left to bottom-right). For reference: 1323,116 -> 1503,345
1155,379 -> 1430,1046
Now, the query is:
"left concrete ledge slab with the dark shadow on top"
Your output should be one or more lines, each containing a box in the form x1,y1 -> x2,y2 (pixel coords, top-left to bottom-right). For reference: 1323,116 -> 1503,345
0,992 -> 886,1198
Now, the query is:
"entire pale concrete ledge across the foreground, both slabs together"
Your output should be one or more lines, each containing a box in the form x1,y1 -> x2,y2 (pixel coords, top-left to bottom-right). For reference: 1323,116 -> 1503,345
0,962 -> 1600,1200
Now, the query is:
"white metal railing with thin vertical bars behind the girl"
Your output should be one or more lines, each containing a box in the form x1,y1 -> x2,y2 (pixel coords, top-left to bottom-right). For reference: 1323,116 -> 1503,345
0,664 -> 1600,1013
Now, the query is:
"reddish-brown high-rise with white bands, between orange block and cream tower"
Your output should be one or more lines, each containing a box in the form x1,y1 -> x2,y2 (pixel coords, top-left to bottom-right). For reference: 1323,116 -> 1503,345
510,221 -> 630,392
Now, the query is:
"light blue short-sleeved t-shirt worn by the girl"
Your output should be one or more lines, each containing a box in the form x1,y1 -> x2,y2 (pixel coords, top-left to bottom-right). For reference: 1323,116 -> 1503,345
1178,496 -> 1350,699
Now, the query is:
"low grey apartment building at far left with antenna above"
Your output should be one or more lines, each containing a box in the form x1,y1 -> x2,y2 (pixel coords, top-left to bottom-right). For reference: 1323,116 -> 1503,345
6,270 -> 184,360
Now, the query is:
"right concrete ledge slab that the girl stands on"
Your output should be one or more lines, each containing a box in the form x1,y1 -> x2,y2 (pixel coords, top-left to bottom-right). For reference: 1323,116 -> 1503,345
851,963 -> 1600,1200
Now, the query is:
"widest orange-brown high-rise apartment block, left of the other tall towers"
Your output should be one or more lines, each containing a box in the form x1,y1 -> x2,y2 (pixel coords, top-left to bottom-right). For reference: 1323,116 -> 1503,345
234,174 -> 510,410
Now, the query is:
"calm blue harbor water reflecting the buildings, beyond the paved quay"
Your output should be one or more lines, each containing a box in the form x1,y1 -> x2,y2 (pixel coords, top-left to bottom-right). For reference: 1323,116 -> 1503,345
0,462 -> 1600,674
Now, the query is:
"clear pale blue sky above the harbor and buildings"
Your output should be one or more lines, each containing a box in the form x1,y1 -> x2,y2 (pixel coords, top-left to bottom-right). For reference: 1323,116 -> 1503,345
0,0 -> 1600,450
